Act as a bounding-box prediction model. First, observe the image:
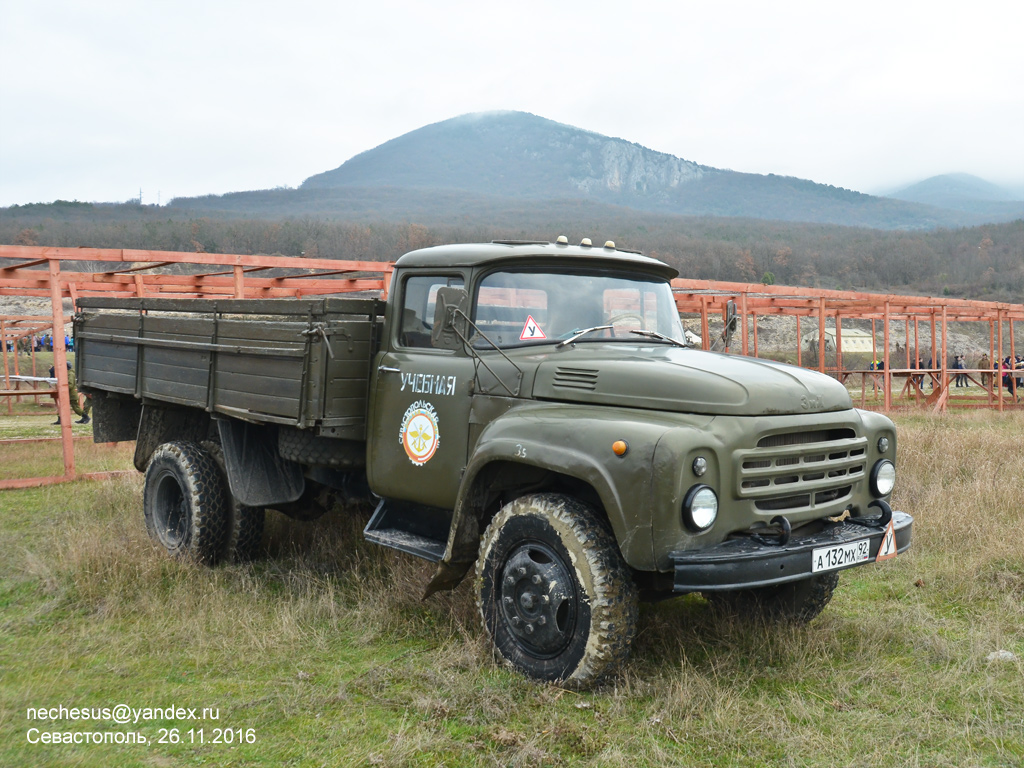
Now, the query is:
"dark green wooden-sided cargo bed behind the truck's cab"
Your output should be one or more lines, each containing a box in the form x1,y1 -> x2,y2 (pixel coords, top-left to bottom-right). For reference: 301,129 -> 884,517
75,298 -> 384,439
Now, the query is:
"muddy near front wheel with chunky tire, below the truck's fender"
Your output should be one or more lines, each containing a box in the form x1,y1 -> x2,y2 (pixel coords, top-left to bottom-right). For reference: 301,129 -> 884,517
475,494 -> 638,687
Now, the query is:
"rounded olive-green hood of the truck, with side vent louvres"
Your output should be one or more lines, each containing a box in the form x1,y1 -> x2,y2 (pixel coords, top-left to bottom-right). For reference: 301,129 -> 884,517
534,343 -> 853,416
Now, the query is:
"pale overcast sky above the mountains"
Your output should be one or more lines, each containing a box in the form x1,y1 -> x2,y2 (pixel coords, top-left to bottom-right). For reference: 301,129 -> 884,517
0,0 -> 1024,206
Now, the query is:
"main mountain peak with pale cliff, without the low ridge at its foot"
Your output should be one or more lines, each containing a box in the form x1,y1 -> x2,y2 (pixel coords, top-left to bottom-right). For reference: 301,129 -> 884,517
300,112 -> 942,228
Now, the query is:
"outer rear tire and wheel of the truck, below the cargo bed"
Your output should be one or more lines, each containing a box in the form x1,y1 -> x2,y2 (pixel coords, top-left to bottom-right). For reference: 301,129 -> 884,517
142,441 -> 227,565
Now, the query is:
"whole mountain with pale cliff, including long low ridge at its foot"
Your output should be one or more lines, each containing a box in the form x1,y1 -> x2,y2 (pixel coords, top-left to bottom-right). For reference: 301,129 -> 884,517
165,112 -> 1021,229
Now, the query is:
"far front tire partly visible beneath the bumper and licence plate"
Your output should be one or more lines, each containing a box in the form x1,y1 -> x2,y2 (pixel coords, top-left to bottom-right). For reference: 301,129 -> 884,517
705,571 -> 839,624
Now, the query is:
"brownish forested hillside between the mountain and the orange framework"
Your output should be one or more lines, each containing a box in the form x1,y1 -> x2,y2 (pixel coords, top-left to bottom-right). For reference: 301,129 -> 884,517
0,202 -> 1024,302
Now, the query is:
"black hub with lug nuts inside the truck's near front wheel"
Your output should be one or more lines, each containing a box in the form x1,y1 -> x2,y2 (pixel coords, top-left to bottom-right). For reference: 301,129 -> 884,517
501,543 -> 577,656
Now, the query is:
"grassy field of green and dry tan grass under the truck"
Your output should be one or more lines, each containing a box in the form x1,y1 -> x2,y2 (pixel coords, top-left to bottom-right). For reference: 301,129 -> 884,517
0,413 -> 1024,767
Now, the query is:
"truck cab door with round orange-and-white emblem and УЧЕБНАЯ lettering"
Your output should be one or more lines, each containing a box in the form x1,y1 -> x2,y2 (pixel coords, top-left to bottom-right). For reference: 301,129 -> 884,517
367,271 -> 474,509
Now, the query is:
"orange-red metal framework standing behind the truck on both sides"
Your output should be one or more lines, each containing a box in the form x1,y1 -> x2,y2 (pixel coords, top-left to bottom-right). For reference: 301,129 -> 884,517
0,245 -> 1024,489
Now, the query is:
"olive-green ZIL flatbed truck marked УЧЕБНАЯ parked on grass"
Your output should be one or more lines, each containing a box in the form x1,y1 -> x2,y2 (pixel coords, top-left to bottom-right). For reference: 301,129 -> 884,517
75,238 -> 912,684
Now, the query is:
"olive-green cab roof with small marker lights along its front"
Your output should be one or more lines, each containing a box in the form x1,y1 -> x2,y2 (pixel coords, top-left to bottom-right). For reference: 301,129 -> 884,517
395,241 -> 679,280
